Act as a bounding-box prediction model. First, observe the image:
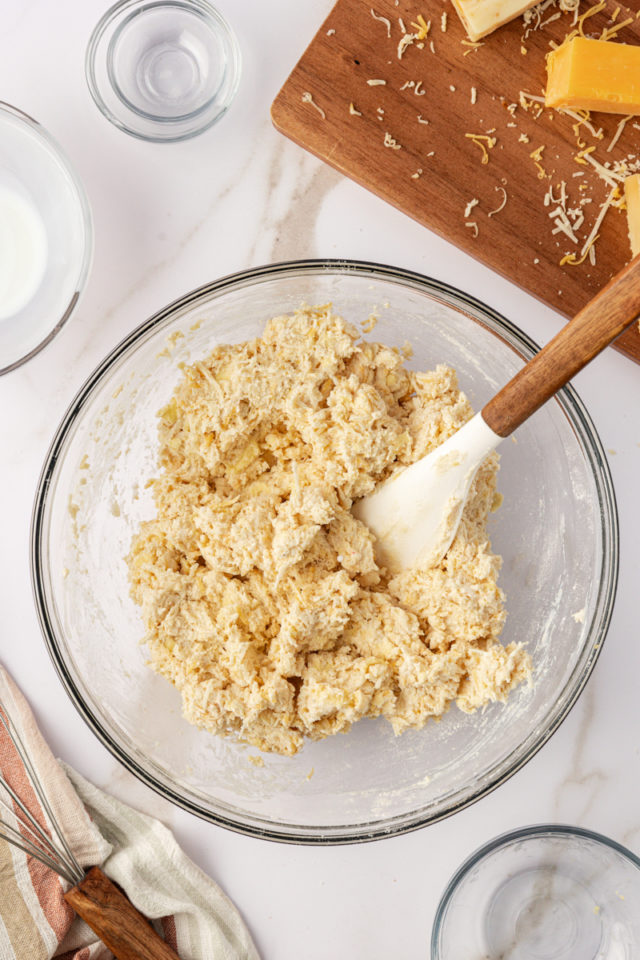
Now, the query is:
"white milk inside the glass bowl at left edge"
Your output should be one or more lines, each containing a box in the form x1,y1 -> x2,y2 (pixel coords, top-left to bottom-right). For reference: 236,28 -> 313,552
0,183 -> 48,320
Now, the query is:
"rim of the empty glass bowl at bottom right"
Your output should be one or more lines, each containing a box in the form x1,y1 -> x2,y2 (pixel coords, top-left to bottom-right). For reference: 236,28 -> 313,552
431,823 -> 640,960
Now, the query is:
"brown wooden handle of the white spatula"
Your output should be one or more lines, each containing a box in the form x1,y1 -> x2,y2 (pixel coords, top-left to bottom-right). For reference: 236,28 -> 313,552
482,255 -> 640,437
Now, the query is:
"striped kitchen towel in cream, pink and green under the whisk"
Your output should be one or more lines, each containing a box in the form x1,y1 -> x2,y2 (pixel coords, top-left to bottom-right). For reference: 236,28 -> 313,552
0,666 -> 259,960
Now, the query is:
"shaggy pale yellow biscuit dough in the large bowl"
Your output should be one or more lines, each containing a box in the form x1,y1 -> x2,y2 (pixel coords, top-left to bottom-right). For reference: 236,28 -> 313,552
128,305 -> 530,755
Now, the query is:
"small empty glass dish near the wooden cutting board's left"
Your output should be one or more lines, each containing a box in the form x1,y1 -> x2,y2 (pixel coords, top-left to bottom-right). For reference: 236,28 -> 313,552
85,0 -> 240,142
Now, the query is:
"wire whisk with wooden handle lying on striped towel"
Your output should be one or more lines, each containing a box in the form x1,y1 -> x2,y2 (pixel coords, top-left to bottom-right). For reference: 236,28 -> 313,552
0,701 -> 179,960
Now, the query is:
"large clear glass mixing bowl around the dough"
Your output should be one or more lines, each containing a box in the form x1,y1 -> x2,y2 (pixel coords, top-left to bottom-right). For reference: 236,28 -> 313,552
32,261 -> 618,843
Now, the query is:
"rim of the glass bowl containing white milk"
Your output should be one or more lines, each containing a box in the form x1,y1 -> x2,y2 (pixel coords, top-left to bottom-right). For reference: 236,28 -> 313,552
0,100 -> 93,376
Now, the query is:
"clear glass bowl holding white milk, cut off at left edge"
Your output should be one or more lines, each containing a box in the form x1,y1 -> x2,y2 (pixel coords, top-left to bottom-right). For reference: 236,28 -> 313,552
0,102 -> 93,373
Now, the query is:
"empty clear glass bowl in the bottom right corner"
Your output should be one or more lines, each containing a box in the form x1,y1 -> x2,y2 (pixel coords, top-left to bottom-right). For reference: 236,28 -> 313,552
431,824 -> 640,960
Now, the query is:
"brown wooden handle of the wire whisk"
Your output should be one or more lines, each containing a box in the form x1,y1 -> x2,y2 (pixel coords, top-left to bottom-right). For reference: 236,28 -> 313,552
64,867 -> 179,960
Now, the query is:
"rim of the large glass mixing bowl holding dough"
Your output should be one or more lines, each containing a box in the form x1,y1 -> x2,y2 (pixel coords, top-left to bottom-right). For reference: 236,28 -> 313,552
30,258 -> 619,846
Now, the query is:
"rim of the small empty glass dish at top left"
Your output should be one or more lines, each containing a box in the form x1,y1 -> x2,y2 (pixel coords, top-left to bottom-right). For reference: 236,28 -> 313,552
84,0 -> 242,143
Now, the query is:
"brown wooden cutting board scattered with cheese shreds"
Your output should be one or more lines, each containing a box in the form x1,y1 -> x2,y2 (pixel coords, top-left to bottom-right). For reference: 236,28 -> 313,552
272,0 -> 640,362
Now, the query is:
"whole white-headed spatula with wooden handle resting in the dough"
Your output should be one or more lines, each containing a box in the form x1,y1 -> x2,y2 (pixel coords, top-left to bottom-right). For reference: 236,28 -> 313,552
353,256 -> 640,572
